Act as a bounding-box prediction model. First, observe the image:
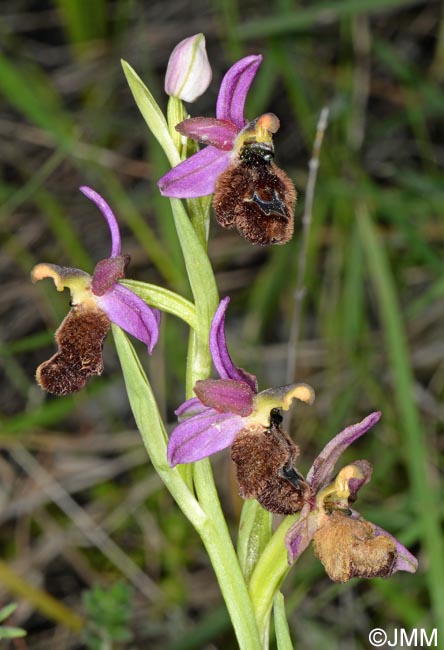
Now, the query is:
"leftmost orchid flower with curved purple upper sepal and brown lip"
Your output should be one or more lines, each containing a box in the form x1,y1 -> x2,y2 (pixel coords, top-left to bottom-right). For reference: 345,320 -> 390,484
31,187 -> 160,395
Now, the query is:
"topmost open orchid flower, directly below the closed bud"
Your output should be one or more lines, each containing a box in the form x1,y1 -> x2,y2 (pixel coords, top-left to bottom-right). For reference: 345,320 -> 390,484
158,55 -> 296,245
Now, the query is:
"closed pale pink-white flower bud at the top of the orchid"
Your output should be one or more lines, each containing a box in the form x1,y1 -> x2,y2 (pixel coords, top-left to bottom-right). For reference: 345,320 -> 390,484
165,34 -> 212,102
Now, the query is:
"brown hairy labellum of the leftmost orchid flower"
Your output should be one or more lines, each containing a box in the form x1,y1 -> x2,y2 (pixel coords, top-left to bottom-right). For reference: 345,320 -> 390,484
36,305 -> 110,396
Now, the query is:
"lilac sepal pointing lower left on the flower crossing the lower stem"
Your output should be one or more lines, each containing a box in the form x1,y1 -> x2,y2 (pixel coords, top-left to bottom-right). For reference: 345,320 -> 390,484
167,408 -> 244,467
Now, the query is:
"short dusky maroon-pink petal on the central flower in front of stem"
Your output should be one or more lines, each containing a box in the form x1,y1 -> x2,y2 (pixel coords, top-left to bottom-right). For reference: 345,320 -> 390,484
194,379 -> 255,418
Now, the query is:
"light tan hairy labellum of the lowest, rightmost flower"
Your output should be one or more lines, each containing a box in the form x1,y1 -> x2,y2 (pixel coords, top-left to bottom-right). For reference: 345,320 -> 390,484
313,512 -> 397,582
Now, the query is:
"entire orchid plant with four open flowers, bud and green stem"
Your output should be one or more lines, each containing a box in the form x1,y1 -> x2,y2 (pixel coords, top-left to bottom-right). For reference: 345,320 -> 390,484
33,34 -> 417,650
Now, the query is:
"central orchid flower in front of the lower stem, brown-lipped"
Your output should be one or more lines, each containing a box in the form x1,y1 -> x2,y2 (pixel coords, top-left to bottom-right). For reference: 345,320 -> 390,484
168,297 -> 314,513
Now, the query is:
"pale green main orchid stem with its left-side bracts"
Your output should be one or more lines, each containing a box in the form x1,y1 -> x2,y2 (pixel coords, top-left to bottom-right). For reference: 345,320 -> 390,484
123,62 -> 260,650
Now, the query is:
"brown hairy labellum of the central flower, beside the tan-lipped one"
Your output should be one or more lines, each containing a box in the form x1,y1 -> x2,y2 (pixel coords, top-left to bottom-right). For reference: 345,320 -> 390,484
231,409 -> 310,515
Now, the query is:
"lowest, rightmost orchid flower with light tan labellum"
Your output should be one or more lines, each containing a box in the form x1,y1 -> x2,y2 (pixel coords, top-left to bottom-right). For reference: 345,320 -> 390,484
285,412 -> 418,582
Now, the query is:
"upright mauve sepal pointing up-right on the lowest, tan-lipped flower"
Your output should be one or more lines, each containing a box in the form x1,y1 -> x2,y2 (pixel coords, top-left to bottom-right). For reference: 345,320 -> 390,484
307,411 -> 381,492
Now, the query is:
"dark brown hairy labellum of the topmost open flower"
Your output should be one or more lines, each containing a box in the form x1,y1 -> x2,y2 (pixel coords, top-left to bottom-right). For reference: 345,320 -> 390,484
213,142 -> 296,246
